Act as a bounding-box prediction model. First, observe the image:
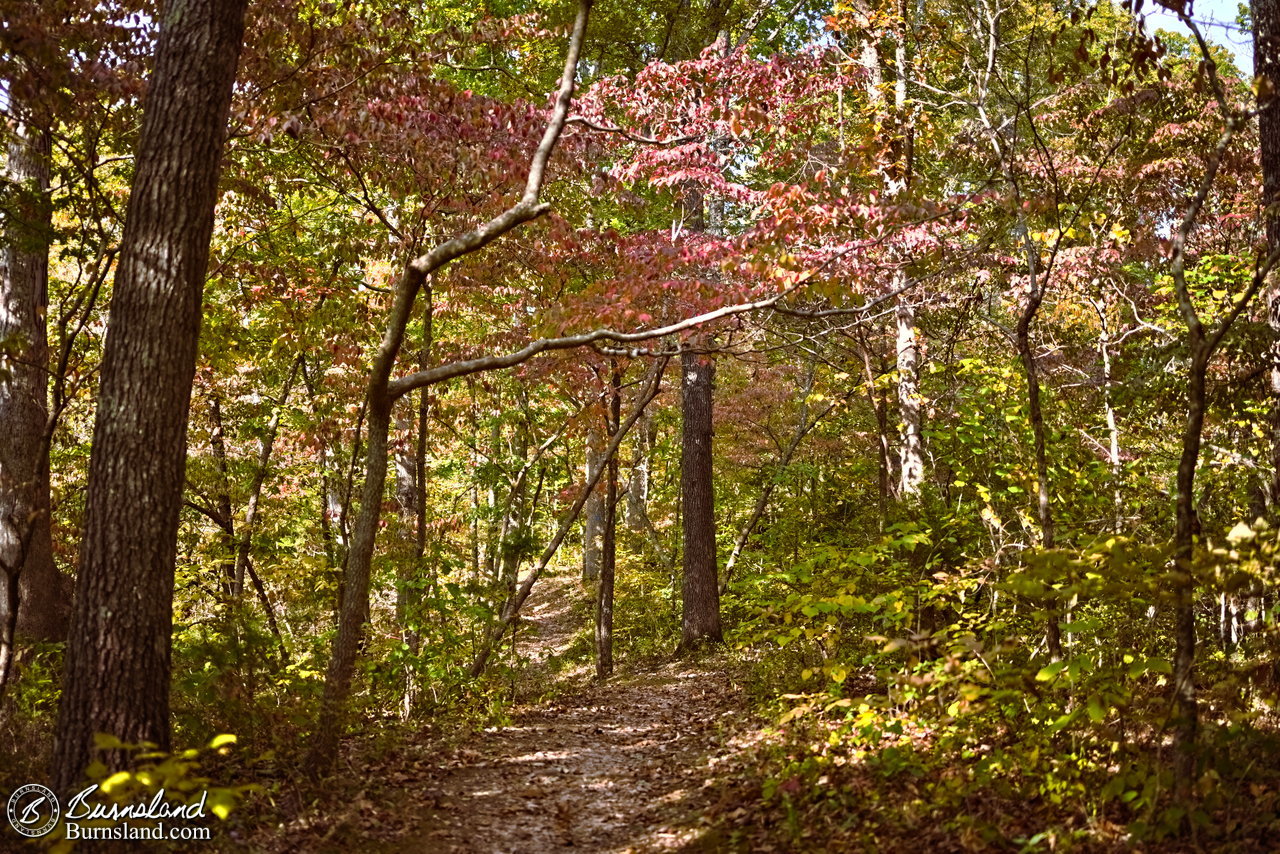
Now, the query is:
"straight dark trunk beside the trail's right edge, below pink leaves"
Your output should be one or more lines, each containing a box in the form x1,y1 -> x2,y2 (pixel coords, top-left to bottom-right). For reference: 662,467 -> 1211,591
680,352 -> 722,650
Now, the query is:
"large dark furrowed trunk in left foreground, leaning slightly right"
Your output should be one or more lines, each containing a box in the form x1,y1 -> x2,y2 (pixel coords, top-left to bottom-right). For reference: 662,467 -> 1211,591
54,0 -> 246,791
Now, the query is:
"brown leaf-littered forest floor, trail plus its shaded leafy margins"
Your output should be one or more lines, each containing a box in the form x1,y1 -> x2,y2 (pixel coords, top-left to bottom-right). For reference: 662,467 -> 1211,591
253,577 -> 762,854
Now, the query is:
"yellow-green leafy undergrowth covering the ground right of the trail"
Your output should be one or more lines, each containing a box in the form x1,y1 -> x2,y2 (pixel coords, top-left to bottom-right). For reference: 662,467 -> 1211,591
691,522 -> 1280,851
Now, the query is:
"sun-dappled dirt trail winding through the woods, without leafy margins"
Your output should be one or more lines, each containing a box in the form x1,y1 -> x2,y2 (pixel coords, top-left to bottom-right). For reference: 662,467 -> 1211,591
402,579 -> 748,854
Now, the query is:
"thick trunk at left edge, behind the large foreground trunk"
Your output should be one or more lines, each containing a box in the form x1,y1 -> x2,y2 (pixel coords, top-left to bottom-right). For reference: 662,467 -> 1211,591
0,102 -> 69,665
